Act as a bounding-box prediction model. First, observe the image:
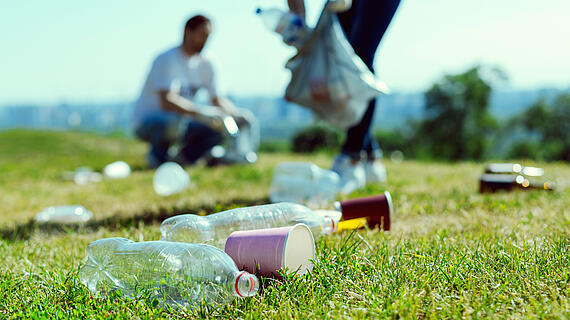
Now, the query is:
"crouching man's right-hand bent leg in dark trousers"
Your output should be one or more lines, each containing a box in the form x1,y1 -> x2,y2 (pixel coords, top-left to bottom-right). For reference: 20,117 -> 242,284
180,121 -> 224,163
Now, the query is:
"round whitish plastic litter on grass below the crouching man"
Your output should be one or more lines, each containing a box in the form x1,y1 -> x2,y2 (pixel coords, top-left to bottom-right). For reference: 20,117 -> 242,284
152,162 -> 190,196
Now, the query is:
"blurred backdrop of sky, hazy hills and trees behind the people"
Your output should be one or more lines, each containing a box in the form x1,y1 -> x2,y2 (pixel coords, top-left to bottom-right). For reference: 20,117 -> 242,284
0,0 -> 570,161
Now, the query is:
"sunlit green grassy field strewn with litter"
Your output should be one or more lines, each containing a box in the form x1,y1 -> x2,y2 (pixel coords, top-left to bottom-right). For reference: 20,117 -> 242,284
0,131 -> 570,319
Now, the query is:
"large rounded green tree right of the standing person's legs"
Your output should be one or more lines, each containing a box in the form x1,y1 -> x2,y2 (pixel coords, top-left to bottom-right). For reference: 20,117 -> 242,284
416,67 -> 497,160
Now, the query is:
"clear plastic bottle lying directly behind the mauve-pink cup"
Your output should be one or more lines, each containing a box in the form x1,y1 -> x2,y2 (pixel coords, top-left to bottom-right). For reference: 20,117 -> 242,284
160,202 -> 342,248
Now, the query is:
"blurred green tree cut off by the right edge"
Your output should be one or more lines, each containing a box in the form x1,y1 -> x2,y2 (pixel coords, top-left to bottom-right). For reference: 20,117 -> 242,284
515,92 -> 570,161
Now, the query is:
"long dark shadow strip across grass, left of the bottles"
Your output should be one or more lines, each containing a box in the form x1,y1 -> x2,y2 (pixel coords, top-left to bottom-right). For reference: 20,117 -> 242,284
0,198 -> 269,242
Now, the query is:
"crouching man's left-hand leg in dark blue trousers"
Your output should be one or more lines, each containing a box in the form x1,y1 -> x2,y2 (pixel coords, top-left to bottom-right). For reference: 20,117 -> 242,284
135,113 -> 178,167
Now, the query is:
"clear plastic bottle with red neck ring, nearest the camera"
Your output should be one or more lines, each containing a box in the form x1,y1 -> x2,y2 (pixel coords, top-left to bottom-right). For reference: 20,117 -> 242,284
79,238 -> 259,306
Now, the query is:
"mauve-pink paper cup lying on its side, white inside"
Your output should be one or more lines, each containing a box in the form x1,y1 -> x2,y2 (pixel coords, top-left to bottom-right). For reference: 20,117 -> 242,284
225,223 -> 315,278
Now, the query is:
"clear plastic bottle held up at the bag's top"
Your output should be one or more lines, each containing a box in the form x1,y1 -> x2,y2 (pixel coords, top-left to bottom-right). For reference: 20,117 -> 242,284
255,8 -> 311,49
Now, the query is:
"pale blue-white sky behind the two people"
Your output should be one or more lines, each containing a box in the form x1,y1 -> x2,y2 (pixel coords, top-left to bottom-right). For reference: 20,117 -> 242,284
0,0 -> 570,105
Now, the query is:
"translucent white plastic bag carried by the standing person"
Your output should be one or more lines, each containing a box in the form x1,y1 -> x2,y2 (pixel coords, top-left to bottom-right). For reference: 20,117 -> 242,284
285,6 -> 388,129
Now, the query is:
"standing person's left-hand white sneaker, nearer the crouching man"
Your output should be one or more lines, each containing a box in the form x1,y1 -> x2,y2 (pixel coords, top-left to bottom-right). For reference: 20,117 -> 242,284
331,154 -> 366,194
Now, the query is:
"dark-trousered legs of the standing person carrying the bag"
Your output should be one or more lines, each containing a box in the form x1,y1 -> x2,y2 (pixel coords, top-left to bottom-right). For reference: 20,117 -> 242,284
339,0 -> 400,158
